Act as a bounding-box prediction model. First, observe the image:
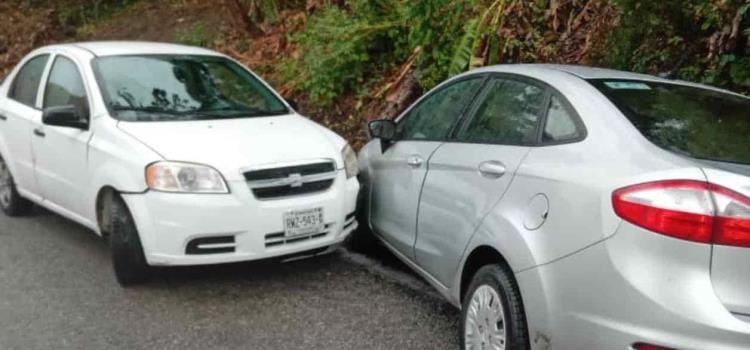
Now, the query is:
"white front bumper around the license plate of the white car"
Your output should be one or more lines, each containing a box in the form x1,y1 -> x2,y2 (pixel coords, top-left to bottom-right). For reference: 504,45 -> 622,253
123,171 -> 359,266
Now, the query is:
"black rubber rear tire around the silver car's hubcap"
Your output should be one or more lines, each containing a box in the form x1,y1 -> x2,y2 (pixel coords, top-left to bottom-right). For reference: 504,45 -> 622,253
461,265 -> 531,350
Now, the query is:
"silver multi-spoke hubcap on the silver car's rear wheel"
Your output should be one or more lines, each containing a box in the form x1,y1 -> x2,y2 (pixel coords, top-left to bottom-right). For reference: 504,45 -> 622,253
464,285 -> 506,350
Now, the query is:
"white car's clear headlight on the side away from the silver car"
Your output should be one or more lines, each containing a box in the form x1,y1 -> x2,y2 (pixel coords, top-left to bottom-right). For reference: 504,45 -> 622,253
146,162 -> 229,193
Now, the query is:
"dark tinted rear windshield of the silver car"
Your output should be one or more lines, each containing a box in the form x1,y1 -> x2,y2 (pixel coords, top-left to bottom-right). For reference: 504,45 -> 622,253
590,80 -> 750,164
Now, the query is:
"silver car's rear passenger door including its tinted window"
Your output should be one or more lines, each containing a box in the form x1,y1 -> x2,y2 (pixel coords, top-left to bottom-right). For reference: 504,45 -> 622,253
415,77 -> 549,287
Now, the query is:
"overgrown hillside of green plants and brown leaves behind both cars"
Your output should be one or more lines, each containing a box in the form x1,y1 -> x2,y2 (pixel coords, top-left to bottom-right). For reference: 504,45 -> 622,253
5,0 -> 750,146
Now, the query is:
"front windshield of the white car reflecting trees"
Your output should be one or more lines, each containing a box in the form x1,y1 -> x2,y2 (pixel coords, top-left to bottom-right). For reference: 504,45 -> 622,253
93,55 -> 289,121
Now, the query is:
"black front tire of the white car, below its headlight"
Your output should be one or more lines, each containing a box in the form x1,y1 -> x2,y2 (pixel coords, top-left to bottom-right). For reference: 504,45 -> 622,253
109,195 -> 151,287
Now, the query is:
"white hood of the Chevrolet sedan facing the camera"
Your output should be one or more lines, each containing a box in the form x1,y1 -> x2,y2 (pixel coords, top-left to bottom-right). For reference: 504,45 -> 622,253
118,115 -> 345,181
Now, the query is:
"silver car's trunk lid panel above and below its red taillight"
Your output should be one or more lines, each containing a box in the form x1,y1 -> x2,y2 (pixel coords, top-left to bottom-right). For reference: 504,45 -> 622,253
703,162 -> 750,316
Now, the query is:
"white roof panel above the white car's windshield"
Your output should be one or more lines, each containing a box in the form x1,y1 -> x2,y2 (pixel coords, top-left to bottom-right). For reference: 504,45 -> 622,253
47,41 -> 222,56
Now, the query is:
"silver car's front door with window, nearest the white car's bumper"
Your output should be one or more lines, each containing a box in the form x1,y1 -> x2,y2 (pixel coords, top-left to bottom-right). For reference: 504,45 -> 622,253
370,75 -> 484,260
